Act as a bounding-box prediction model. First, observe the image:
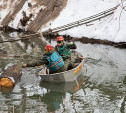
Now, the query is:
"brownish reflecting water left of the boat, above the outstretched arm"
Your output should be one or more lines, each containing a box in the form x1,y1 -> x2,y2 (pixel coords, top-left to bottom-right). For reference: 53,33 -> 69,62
0,32 -> 46,69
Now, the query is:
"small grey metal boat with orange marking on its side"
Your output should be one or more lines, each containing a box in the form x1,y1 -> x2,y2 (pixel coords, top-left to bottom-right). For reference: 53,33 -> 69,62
38,51 -> 84,82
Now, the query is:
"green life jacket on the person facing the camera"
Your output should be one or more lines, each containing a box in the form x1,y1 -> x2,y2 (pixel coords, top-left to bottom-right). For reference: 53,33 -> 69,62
56,43 -> 71,59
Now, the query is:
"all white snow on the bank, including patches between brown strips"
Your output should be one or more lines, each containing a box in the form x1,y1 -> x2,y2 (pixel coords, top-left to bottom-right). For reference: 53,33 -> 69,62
0,0 -> 126,42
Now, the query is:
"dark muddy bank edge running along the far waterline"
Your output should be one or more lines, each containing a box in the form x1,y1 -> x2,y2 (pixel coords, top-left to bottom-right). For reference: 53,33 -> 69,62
0,27 -> 126,49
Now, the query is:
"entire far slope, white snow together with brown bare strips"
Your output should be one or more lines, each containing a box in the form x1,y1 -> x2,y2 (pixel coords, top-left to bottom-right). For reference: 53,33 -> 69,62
0,0 -> 126,42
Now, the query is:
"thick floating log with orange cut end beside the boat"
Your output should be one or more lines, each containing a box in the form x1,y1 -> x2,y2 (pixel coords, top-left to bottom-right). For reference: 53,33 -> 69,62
0,65 -> 22,87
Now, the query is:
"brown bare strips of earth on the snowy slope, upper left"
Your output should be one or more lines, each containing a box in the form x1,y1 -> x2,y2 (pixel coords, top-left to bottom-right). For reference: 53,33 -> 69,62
0,0 -> 67,32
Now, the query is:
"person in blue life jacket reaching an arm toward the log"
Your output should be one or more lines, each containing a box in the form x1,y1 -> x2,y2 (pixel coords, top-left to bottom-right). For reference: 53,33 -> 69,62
22,45 -> 64,74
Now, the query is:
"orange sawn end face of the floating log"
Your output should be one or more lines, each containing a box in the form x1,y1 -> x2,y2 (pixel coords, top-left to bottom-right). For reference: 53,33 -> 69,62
0,78 -> 14,87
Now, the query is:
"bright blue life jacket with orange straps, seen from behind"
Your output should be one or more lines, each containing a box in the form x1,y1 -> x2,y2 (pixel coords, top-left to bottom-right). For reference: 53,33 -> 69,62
45,51 -> 64,72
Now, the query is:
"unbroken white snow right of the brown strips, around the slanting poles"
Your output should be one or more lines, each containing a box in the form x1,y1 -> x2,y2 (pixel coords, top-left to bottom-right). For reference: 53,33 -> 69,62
47,0 -> 126,42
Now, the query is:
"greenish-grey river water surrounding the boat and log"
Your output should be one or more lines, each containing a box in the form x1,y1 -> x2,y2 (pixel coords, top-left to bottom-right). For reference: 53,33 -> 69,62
0,32 -> 126,113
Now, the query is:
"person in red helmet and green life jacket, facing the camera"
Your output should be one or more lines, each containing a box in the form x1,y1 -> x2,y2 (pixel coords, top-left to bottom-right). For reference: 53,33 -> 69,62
55,36 -> 77,70
